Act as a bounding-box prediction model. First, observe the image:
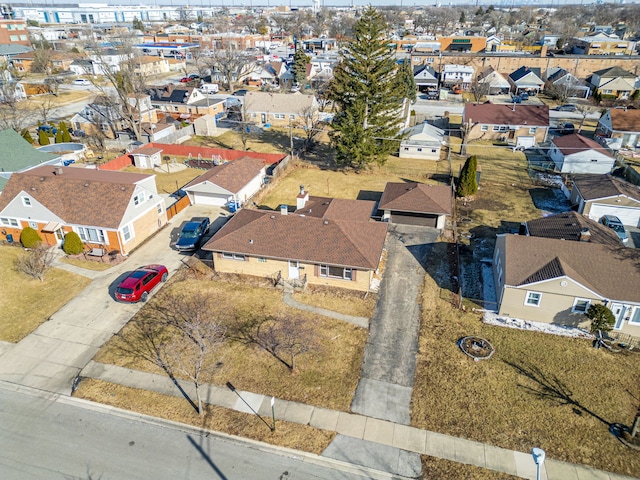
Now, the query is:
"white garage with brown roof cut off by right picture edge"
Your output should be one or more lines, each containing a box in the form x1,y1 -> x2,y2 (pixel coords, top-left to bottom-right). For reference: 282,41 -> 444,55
571,175 -> 640,227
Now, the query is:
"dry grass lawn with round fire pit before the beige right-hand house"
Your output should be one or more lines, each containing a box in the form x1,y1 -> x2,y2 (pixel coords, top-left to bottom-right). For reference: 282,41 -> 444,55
412,246 -> 640,478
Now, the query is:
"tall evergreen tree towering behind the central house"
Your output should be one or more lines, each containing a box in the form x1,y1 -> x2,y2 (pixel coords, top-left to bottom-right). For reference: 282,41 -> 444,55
330,7 -> 407,170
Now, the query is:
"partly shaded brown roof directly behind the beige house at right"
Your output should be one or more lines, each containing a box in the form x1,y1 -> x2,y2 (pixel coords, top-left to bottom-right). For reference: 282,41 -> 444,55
527,212 -> 621,247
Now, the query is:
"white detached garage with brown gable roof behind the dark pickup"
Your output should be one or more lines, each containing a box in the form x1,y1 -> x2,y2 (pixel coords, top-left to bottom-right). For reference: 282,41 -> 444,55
183,157 -> 266,207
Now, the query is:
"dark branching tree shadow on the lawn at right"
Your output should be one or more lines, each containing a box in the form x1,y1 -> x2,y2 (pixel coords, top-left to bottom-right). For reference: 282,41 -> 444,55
504,360 -> 614,428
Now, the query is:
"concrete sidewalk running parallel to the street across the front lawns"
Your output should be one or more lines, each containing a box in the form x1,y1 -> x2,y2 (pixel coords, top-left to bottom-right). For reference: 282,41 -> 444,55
80,361 -> 632,480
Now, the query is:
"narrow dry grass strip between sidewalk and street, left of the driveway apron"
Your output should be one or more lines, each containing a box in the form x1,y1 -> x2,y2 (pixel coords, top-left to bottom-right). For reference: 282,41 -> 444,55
73,379 -> 335,455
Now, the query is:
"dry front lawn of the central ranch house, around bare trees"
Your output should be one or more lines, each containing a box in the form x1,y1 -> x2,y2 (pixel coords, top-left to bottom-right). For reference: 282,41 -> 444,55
95,277 -> 367,411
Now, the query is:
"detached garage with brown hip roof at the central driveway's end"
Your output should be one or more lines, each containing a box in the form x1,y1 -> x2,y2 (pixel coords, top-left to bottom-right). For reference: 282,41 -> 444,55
378,182 -> 453,230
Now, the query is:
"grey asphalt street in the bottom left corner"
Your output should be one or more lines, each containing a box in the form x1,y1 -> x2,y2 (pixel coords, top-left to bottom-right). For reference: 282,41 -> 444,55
0,383 -> 392,480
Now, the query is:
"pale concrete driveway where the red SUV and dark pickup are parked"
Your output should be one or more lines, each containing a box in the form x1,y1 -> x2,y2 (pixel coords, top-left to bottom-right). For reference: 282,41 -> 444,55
0,206 -> 228,395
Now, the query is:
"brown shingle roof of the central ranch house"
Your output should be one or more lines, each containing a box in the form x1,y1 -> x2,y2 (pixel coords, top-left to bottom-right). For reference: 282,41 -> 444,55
203,200 -> 387,270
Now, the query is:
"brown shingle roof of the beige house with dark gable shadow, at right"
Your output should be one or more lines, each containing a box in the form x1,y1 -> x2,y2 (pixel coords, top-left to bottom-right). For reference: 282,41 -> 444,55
505,234 -> 640,302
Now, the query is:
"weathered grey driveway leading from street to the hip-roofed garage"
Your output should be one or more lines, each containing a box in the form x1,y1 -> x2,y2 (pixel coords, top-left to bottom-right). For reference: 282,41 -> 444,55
323,225 -> 439,478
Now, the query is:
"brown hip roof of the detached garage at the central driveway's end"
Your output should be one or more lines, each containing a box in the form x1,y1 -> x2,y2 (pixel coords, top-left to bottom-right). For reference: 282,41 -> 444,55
378,182 -> 452,215
